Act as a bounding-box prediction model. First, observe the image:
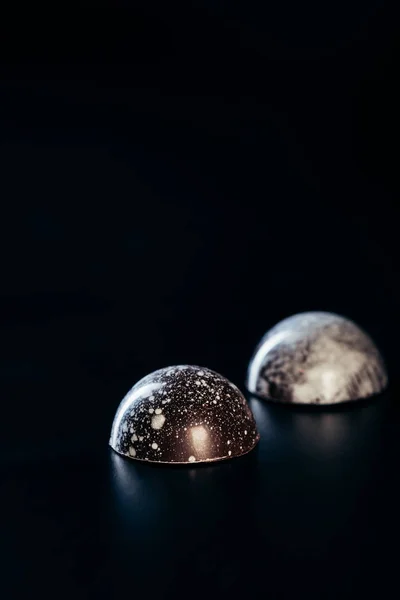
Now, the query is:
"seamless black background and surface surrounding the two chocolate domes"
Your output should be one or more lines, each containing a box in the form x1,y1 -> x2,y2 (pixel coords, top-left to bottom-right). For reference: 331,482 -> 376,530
0,0 -> 399,599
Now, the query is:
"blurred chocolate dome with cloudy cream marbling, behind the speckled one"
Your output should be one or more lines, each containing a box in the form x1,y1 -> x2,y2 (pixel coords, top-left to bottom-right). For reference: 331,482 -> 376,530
246,312 -> 387,404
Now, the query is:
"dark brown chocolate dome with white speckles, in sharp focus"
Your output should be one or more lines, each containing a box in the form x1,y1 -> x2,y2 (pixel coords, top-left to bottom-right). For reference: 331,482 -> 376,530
110,365 -> 259,463
